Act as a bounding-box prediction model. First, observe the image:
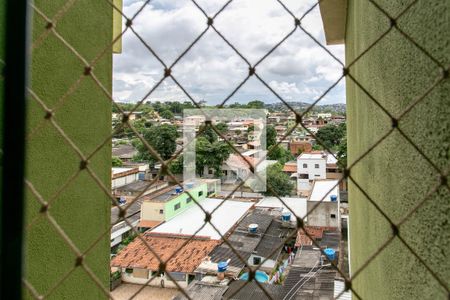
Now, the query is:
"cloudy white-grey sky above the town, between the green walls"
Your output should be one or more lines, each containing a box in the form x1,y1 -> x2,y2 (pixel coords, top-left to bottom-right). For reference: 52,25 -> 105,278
114,0 -> 345,104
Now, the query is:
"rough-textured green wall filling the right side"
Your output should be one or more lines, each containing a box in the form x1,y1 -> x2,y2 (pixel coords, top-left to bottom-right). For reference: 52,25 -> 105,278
346,0 -> 450,299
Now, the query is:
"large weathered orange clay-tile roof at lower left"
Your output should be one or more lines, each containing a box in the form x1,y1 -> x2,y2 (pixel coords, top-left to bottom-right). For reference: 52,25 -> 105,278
111,234 -> 220,273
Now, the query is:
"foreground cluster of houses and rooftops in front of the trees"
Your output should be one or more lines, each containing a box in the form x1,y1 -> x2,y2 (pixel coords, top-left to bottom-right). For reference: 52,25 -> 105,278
111,163 -> 350,299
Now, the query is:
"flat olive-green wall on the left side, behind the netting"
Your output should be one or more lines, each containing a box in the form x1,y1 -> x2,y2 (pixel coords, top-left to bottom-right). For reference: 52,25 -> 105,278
25,0 -> 112,299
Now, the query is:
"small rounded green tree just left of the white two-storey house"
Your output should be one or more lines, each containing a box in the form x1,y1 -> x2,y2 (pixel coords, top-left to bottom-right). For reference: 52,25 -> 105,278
264,163 -> 294,196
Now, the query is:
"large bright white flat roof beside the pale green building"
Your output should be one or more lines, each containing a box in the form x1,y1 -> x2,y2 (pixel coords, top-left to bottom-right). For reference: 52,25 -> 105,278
152,198 -> 253,240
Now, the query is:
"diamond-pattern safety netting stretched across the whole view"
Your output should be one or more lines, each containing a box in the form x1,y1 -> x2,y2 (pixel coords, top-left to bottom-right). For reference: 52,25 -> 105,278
14,0 -> 450,299
